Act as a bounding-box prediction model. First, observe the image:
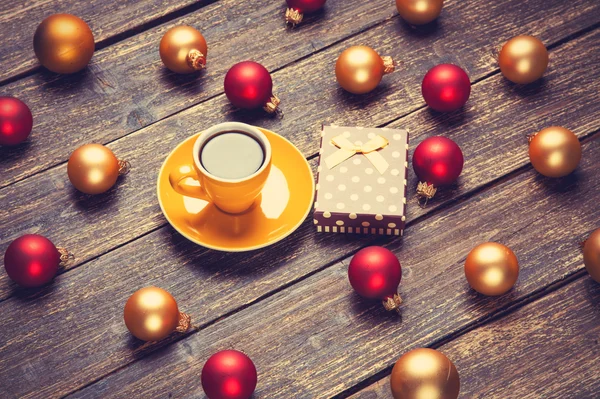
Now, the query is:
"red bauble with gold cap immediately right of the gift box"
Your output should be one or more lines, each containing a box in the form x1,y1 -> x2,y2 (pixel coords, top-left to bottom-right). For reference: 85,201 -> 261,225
413,136 -> 464,205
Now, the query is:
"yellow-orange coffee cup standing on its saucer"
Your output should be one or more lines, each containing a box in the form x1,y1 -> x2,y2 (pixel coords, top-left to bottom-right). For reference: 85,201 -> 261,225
169,122 -> 271,213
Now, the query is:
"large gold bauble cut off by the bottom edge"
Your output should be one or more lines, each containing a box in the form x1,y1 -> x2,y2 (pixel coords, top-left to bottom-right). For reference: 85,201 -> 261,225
390,348 -> 460,399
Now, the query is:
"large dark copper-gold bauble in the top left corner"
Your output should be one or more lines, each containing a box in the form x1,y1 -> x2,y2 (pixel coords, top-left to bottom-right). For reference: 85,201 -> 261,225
33,14 -> 94,73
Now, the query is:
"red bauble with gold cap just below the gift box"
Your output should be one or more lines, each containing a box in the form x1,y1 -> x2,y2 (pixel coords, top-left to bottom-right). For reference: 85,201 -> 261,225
348,246 -> 402,310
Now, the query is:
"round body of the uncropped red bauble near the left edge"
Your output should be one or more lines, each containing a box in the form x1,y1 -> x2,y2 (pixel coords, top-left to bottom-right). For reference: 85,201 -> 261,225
4,234 -> 60,288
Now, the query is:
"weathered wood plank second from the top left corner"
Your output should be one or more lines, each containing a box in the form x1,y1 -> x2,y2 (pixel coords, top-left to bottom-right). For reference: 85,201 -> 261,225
0,0 -> 404,186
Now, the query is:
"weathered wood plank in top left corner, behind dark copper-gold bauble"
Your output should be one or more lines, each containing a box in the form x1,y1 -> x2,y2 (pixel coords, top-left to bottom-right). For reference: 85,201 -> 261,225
0,0 -> 207,81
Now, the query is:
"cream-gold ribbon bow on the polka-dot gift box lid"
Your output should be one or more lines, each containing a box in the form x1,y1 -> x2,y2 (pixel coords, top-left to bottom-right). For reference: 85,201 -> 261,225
325,135 -> 390,174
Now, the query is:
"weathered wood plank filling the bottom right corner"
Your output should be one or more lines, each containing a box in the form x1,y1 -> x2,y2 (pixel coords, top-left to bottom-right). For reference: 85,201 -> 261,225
351,275 -> 600,399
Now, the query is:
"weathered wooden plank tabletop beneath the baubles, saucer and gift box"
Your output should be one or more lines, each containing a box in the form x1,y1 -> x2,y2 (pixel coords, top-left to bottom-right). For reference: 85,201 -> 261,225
0,0 -> 600,399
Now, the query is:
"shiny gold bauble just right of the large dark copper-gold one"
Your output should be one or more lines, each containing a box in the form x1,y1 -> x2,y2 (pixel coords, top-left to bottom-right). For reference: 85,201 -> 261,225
159,25 -> 208,73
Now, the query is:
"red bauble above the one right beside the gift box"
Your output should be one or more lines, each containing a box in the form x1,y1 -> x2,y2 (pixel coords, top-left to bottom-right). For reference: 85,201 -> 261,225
421,64 -> 471,112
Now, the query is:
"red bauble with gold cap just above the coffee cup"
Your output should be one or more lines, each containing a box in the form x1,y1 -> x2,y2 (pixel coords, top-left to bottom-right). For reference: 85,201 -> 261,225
225,61 -> 279,113
